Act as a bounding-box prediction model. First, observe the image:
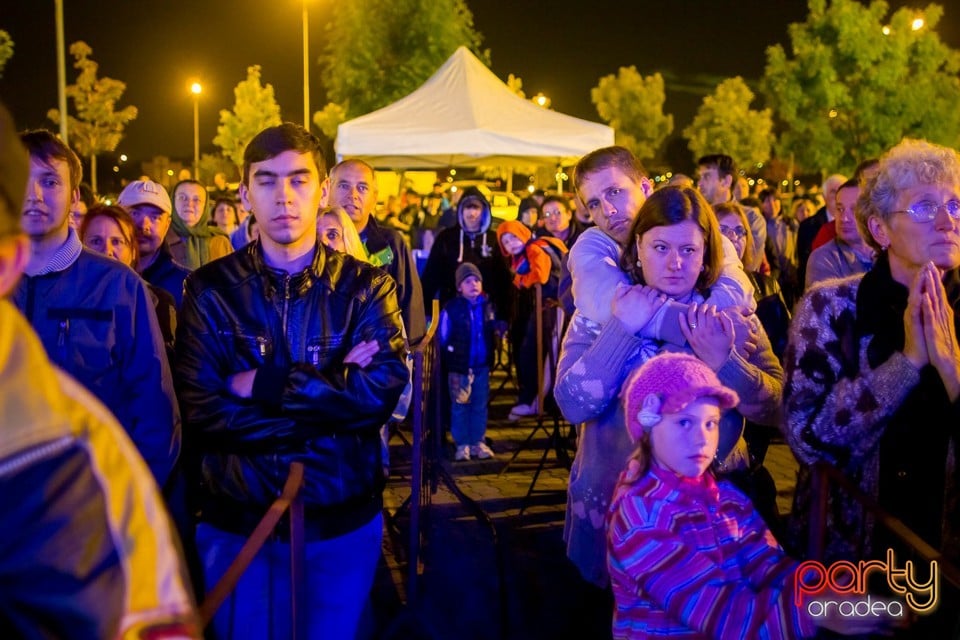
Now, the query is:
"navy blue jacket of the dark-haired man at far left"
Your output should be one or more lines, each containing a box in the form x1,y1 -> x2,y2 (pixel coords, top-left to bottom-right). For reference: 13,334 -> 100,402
13,249 -> 180,486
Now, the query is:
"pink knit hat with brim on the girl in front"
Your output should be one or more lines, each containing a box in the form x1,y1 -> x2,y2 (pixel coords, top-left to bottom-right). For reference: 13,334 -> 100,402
623,353 -> 740,441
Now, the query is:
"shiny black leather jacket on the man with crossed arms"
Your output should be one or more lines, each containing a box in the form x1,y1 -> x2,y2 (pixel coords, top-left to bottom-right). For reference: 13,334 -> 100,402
175,242 -> 408,539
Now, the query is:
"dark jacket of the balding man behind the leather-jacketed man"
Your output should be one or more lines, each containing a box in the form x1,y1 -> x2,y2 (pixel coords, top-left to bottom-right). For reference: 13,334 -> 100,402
361,216 -> 427,344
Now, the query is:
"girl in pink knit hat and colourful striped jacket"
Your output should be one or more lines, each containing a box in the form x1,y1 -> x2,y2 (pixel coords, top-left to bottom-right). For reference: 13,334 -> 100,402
607,353 -> 896,640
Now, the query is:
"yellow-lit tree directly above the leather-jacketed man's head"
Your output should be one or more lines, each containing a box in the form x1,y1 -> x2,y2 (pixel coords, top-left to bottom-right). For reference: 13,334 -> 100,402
213,64 -> 281,169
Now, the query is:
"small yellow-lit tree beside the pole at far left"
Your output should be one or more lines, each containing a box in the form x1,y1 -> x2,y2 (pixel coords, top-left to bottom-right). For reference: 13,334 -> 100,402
47,41 -> 137,193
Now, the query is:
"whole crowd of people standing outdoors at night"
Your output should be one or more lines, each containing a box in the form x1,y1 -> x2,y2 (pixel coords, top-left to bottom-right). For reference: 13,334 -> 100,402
0,90 -> 960,638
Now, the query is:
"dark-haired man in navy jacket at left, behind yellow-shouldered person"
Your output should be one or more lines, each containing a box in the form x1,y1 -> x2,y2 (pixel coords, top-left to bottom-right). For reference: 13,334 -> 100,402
13,130 -> 180,486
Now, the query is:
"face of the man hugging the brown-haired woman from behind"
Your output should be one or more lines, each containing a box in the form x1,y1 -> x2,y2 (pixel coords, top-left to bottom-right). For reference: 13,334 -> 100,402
580,166 -> 650,246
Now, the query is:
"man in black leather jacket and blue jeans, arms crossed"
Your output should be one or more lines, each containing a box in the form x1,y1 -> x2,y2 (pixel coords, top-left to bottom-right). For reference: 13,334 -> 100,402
176,123 -> 408,638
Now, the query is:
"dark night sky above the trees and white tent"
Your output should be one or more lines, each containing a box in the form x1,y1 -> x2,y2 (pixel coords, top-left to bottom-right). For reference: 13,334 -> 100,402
0,0 -> 960,171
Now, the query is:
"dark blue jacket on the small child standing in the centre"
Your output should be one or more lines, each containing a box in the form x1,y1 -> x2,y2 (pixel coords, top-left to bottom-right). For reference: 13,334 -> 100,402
438,294 -> 495,375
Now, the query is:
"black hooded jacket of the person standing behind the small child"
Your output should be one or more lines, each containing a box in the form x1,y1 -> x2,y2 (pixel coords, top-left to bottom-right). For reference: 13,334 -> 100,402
423,187 -> 513,320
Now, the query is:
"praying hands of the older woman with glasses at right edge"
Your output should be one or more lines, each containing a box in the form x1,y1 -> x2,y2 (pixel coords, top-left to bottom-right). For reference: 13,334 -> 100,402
921,262 -> 960,401
